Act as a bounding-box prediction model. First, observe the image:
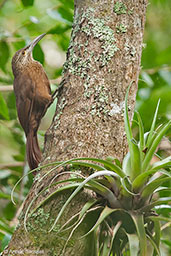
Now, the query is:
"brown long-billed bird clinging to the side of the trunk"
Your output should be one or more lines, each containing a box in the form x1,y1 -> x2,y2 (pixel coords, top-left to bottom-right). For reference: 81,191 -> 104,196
12,33 -> 53,170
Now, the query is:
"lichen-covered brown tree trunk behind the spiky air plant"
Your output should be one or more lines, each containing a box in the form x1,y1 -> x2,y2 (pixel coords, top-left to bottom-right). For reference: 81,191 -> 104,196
3,0 -> 147,256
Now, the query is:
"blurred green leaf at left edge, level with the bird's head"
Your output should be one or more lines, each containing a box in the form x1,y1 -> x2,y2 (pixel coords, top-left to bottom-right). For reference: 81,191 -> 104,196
0,41 -> 10,72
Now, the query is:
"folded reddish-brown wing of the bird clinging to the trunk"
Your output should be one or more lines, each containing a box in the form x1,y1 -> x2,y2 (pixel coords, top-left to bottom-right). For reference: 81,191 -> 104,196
14,75 -> 35,136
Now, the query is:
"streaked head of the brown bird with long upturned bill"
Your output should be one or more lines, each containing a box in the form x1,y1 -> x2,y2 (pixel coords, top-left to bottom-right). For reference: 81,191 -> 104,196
12,33 -> 46,75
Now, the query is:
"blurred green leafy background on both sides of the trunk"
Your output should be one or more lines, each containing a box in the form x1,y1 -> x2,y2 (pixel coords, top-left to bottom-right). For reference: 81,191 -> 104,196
0,0 -> 171,255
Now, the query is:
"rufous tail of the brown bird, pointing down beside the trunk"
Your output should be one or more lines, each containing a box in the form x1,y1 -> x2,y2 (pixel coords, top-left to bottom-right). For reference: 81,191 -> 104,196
26,131 -> 41,170
